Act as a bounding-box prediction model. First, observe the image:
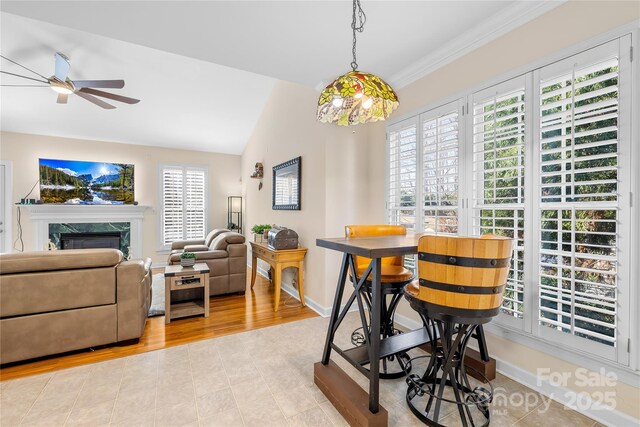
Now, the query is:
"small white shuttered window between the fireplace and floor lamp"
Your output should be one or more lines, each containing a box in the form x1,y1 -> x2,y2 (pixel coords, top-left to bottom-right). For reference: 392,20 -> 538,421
160,166 -> 207,248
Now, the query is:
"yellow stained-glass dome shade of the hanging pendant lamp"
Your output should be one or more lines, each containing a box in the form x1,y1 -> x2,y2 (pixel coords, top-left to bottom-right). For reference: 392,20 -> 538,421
318,70 -> 399,126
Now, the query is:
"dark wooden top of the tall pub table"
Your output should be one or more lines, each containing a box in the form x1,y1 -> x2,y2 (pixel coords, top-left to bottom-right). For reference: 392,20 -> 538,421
316,234 -> 423,258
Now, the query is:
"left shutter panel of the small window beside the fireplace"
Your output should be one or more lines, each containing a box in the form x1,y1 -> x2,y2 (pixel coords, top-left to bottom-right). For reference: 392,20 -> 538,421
162,168 -> 184,246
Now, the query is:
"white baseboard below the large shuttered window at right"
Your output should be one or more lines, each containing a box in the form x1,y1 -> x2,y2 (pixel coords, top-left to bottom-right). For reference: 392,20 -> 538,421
395,313 -> 638,426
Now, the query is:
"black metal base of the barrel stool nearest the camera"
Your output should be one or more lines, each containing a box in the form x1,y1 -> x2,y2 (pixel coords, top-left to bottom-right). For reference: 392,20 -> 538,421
406,314 -> 493,427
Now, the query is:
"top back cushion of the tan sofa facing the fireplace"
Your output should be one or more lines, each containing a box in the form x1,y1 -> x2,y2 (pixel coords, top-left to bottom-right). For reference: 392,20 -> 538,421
0,249 -> 122,275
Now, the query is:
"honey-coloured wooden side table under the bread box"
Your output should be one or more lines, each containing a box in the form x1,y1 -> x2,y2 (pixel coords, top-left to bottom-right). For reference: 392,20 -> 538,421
250,242 -> 307,311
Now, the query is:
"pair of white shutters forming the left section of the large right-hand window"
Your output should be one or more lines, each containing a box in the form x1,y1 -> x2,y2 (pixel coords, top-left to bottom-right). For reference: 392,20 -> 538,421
387,100 -> 464,269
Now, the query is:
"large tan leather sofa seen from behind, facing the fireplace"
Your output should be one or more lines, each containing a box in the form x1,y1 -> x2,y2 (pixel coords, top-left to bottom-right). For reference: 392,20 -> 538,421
0,249 -> 151,364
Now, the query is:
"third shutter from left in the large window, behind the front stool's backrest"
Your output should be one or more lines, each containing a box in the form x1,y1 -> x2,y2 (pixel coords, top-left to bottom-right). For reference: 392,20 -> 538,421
472,78 -> 528,327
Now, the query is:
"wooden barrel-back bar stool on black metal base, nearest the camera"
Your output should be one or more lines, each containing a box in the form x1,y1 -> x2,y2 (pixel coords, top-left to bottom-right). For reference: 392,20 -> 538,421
404,235 -> 513,426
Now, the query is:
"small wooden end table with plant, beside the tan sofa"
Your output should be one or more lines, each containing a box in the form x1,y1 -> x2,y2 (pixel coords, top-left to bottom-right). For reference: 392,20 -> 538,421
164,263 -> 209,324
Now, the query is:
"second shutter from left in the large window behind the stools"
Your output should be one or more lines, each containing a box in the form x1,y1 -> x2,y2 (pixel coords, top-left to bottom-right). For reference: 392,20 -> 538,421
421,101 -> 462,234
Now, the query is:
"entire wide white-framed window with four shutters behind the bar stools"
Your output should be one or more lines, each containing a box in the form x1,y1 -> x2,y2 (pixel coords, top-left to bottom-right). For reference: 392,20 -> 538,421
387,35 -> 639,365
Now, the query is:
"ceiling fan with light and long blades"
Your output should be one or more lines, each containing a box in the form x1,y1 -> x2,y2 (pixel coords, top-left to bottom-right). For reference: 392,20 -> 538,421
0,52 -> 140,110
